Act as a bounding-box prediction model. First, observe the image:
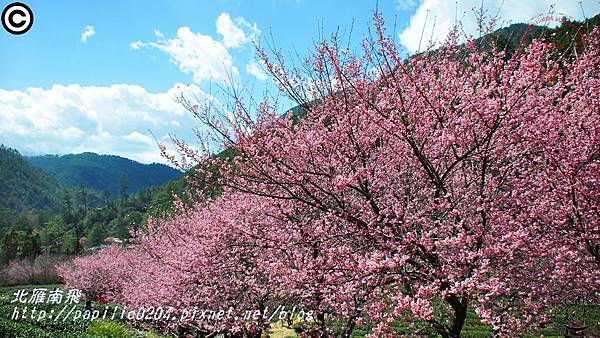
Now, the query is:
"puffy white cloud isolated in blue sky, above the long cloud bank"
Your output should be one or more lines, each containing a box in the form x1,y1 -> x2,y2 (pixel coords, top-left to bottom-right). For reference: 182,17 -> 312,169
130,13 -> 260,84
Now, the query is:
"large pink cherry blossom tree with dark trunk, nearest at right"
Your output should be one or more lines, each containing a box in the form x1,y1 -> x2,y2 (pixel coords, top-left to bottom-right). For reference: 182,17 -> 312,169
170,17 -> 598,337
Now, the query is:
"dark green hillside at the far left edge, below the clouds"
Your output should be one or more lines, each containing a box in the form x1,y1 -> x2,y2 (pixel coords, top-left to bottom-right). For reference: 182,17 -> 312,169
0,145 -> 63,213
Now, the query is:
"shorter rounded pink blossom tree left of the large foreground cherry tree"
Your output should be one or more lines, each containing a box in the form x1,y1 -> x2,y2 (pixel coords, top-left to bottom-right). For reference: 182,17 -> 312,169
121,193 -> 371,336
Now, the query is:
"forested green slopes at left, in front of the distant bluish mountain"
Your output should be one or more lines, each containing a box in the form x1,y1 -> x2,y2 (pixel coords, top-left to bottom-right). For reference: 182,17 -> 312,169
0,151 -> 188,264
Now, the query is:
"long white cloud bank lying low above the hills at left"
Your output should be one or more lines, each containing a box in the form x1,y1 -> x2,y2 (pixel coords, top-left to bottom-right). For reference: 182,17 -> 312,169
0,84 -> 207,163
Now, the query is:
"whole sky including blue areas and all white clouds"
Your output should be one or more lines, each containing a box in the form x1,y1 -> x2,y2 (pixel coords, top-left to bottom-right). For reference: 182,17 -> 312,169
0,0 -> 600,162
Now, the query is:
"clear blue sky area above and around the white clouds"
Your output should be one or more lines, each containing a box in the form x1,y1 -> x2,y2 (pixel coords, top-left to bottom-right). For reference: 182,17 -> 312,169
0,0 -> 410,92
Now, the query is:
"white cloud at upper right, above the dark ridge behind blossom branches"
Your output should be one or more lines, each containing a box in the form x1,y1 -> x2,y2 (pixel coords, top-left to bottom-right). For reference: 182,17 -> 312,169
398,0 -> 600,52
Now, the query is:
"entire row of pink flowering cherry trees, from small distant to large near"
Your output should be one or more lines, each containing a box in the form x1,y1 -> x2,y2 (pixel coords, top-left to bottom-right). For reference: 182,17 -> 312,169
62,16 -> 600,337
